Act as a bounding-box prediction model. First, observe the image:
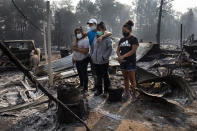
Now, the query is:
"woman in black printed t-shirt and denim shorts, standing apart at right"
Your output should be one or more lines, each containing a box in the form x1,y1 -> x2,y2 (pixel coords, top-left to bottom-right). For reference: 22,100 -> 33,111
117,20 -> 139,100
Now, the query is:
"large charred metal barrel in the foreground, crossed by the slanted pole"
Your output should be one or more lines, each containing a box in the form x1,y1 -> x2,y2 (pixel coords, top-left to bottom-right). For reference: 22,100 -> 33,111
57,85 -> 87,124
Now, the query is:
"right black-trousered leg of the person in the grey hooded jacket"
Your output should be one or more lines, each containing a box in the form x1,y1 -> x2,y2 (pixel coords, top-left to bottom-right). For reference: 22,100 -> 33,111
102,63 -> 111,93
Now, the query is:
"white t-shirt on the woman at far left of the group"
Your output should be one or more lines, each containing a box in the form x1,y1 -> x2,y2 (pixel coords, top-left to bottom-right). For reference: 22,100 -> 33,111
73,37 -> 89,61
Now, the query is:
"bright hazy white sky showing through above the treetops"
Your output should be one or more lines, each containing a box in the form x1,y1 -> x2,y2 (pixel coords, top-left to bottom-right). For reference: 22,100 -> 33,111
50,0 -> 197,13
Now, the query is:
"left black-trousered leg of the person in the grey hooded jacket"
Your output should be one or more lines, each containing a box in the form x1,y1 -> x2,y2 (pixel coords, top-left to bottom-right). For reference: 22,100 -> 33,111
95,64 -> 102,96
